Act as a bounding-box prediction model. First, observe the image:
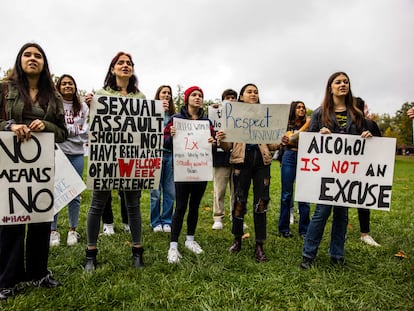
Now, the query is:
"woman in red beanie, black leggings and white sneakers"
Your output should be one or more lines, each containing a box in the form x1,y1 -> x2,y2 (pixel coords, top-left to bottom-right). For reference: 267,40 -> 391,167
164,86 -> 215,263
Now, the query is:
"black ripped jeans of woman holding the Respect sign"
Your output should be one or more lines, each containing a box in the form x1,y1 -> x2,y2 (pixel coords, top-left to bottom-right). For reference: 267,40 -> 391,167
232,149 -> 270,242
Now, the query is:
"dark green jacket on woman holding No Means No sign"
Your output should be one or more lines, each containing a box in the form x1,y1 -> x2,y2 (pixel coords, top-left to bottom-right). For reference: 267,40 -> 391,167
0,81 -> 68,143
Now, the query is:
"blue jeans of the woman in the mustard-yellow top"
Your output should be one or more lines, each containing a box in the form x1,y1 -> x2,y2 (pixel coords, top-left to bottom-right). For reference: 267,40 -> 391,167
279,149 -> 310,235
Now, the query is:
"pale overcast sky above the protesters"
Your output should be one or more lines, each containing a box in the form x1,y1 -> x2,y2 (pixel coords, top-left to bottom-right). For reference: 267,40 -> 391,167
0,0 -> 414,116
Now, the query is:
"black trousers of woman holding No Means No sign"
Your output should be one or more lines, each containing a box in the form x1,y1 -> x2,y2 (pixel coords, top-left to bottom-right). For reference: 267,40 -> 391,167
0,222 -> 51,288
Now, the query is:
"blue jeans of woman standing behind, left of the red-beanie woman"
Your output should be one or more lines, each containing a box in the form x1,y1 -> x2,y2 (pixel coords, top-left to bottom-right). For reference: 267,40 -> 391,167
150,151 -> 175,228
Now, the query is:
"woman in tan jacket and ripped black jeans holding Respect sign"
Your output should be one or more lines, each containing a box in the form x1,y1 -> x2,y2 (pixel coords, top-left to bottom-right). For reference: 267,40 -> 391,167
217,83 -> 278,262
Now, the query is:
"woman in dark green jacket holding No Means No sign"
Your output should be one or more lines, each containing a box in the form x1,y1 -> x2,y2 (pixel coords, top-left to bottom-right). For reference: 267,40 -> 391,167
0,43 -> 68,300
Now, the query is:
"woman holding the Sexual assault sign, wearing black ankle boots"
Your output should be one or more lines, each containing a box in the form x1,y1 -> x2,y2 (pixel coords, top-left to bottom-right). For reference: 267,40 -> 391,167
85,52 -> 145,272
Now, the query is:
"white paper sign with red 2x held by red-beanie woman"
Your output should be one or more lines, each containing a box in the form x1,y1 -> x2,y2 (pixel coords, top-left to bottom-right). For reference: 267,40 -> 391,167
173,118 -> 213,181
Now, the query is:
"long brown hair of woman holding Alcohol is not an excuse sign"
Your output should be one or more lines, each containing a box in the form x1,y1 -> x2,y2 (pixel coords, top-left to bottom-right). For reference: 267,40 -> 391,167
321,71 -> 363,128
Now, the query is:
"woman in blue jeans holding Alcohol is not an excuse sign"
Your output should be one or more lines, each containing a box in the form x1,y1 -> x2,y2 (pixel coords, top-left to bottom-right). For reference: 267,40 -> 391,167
301,72 -> 372,269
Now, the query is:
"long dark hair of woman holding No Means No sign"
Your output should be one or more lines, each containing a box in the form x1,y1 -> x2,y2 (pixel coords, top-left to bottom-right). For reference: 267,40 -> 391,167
7,42 -> 55,111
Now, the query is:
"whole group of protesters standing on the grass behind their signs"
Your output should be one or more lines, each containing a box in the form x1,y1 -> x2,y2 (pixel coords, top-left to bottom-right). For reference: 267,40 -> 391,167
0,43 -> 414,300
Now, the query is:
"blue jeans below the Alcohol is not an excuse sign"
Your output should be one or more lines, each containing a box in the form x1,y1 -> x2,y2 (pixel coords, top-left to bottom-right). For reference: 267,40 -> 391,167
302,204 -> 348,259
